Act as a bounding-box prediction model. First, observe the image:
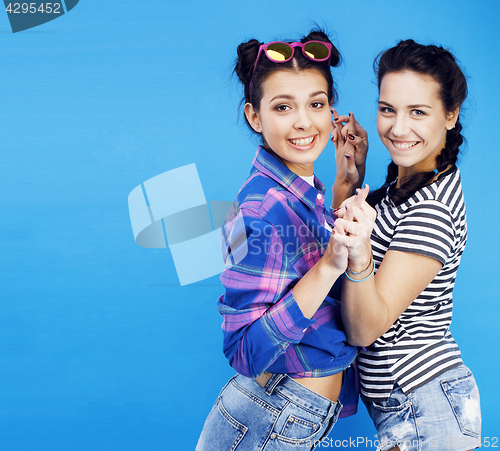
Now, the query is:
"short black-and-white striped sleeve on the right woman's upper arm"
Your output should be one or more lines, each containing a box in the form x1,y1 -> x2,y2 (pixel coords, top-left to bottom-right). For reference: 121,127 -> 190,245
388,200 -> 455,265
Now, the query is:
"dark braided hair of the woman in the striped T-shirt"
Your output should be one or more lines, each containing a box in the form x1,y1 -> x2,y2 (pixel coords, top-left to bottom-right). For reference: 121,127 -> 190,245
367,39 -> 467,206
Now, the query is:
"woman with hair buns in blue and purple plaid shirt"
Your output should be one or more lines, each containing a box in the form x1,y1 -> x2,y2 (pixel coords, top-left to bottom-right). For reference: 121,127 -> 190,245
196,31 -> 368,451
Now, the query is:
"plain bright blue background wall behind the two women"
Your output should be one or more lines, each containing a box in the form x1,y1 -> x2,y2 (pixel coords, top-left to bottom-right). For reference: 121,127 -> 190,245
0,0 -> 500,451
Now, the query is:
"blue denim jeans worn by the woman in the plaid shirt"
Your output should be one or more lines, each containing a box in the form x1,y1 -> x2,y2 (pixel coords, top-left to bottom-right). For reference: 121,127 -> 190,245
196,374 -> 342,451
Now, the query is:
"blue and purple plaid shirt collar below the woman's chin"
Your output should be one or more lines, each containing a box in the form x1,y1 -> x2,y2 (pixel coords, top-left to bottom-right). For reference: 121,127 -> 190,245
253,146 -> 325,210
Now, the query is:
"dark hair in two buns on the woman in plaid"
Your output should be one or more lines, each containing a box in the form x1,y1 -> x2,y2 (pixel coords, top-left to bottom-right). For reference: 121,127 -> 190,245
234,29 -> 341,131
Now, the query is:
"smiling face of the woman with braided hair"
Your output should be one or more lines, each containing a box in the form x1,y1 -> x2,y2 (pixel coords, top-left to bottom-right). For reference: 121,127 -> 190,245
377,71 -> 458,181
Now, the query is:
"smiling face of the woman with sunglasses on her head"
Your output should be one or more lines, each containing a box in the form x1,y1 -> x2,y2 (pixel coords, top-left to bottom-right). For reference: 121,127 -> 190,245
245,69 -> 332,176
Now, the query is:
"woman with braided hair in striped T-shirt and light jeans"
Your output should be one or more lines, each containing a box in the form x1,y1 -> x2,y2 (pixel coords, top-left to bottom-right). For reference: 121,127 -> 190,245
335,40 -> 481,451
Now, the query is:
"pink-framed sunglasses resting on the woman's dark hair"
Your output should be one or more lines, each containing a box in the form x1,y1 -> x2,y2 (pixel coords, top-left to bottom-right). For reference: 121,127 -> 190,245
249,41 -> 332,96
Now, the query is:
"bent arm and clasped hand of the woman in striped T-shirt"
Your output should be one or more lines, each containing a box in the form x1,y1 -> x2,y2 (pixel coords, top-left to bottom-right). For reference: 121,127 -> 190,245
334,197 -> 446,346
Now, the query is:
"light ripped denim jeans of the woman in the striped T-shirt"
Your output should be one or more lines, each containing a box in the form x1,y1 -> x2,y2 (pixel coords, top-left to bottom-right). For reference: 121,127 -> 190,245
365,365 -> 481,451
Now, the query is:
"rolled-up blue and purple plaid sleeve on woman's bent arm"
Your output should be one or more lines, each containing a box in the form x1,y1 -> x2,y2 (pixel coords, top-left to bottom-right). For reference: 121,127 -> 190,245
218,209 -> 315,377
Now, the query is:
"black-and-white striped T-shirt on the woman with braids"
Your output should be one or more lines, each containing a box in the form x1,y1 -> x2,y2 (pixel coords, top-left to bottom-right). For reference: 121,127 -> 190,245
358,167 -> 467,402
